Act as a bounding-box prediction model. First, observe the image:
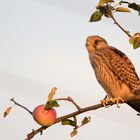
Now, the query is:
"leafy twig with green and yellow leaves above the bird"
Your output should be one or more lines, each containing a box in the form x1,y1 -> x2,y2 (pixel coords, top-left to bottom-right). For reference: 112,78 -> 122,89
89,0 -> 140,49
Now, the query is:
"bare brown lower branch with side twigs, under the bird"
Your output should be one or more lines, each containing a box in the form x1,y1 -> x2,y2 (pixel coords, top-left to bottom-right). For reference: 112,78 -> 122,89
10,95 -> 140,140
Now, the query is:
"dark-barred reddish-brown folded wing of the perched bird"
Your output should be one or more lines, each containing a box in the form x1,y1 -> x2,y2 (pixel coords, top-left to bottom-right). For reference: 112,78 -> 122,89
106,47 -> 140,92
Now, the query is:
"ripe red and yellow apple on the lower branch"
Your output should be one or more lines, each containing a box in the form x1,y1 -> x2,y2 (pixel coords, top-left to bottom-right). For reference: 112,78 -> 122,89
33,104 -> 56,126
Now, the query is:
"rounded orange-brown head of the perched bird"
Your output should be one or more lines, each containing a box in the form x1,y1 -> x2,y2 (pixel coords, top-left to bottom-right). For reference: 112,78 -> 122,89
86,35 -> 108,53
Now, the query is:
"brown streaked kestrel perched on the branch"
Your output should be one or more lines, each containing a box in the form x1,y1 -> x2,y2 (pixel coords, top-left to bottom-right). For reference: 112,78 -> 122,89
86,35 -> 140,112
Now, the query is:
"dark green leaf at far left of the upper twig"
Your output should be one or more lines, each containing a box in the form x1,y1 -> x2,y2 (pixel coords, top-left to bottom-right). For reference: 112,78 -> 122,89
89,11 -> 103,22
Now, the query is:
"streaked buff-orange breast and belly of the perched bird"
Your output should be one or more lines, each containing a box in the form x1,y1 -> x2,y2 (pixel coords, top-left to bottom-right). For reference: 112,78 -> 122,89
90,54 -> 131,98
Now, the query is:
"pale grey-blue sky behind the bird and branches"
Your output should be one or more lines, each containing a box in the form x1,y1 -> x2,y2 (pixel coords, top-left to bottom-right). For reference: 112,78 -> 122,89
0,0 -> 140,140
